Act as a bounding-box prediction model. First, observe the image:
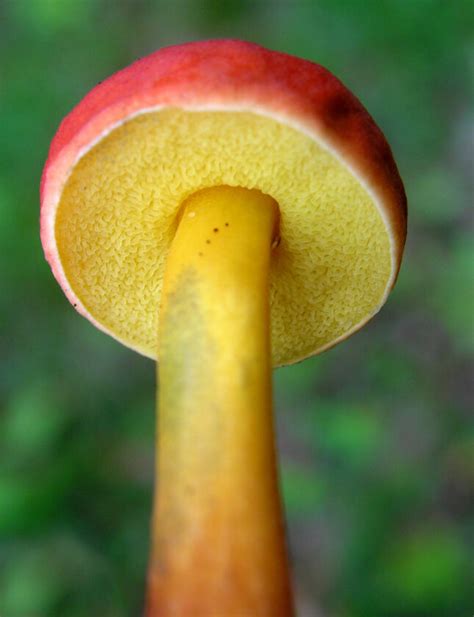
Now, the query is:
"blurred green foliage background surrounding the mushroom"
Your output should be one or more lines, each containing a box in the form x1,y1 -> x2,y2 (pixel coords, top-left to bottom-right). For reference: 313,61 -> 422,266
0,0 -> 474,617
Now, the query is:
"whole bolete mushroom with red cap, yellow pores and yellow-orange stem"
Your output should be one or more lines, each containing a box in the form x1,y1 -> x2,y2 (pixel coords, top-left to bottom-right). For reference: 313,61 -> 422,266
41,40 -> 406,617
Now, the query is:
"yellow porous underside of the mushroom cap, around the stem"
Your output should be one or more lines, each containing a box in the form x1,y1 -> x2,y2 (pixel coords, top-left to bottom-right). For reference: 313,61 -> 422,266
55,108 -> 392,365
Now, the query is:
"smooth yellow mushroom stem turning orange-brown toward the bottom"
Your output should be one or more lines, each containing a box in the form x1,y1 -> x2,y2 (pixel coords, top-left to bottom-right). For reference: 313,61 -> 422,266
146,186 -> 293,617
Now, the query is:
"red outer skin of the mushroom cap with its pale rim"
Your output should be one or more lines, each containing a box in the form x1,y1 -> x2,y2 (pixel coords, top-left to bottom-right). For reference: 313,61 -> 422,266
41,40 -> 406,362
